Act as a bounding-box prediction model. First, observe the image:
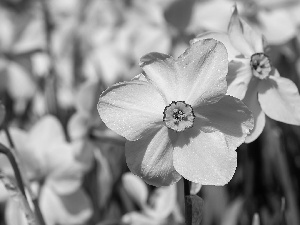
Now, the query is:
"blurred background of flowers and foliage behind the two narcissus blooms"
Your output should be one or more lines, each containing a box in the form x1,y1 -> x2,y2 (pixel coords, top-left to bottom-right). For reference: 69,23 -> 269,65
0,0 -> 300,225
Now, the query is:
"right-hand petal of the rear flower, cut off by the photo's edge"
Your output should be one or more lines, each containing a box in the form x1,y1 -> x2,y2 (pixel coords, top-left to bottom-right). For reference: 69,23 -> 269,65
258,76 -> 300,125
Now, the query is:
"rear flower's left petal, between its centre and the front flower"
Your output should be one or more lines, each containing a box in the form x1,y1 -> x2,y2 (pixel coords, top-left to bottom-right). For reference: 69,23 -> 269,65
227,58 -> 252,100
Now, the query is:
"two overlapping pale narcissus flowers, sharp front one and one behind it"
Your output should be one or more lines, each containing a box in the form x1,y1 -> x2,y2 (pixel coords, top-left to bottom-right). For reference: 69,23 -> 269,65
98,3 -> 300,186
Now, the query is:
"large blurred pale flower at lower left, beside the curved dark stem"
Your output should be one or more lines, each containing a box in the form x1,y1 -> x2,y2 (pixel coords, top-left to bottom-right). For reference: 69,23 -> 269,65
0,116 -> 92,225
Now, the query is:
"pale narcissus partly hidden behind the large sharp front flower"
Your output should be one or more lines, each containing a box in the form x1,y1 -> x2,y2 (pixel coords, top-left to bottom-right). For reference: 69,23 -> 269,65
194,6 -> 300,142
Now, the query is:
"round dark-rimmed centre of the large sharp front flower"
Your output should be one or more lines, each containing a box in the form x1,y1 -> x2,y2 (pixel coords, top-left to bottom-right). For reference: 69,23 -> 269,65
163,101 -> 195,132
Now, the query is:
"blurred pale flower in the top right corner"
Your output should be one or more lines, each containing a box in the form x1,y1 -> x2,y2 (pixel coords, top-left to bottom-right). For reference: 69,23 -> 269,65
238,0 -> 300,45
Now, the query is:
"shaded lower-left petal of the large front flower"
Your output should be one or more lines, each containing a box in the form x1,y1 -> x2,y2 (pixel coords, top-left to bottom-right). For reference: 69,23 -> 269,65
125,126 -> 181,186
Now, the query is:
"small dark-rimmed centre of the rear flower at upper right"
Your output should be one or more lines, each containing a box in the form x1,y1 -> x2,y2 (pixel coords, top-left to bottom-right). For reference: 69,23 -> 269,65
250,53 -> 271,80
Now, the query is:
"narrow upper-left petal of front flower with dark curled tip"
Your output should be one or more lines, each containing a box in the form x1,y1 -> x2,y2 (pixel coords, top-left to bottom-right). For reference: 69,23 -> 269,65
140,52 -> 178,104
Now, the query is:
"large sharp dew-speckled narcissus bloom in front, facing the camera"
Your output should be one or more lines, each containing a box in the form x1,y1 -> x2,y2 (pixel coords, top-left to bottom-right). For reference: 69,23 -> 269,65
98,39 -> 253,186
